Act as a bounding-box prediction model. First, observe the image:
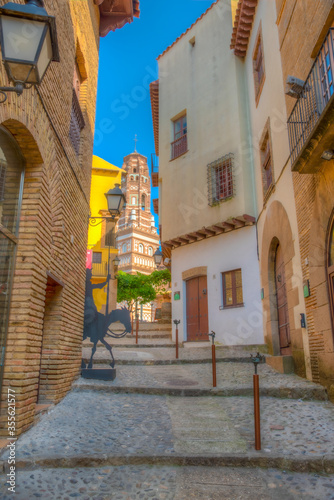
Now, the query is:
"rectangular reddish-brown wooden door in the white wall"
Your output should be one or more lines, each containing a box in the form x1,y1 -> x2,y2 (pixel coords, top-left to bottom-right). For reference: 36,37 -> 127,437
186,276 -> 209,342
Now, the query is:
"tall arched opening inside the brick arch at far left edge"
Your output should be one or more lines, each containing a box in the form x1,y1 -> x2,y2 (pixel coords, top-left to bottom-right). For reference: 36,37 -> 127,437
0,127 -> 24,388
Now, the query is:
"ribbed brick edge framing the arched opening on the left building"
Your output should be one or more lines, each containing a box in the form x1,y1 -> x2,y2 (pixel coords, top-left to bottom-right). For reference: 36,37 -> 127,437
1,118 -> 61,434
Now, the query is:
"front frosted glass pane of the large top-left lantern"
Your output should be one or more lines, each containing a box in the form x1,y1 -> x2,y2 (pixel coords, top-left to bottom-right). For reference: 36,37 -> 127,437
1,15 -> 45,63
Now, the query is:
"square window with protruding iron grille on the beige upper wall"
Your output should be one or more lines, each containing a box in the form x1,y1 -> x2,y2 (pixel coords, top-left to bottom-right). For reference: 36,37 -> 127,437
207,153 -> 235,207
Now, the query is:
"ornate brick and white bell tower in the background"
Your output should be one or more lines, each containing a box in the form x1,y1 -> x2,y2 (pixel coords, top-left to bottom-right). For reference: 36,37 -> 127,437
116,151 -> 159,280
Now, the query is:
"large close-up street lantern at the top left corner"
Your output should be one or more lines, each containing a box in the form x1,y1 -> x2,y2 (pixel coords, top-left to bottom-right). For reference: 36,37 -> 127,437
0,0 -> 60,102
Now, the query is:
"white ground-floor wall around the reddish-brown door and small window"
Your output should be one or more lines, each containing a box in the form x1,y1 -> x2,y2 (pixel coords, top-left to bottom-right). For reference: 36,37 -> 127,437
172,226 -> 264,345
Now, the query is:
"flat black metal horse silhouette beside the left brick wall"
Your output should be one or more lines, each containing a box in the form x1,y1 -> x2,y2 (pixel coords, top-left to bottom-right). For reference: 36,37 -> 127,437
81,269 -> 131,369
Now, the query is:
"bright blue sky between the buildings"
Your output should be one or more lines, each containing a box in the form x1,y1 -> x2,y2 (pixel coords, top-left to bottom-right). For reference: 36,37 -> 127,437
94,0 -> 214,222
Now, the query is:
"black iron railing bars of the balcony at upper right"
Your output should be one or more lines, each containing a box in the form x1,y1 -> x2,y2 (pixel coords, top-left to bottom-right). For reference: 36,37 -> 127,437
288,28 -> 334,165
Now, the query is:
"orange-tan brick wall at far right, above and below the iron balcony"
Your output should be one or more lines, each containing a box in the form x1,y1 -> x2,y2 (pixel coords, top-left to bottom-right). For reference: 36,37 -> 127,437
276,0 -> 334,386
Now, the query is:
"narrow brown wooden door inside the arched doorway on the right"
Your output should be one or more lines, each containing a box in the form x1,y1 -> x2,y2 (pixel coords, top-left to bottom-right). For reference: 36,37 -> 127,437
275,245 -> 292,356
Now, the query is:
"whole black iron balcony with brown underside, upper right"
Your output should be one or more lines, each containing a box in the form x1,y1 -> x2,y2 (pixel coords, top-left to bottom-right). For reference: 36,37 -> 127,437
288,28 -> 334,173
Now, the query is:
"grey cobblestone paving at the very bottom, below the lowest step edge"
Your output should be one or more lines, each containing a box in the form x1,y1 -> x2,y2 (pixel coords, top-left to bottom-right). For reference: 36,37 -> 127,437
0,462 -> 334,500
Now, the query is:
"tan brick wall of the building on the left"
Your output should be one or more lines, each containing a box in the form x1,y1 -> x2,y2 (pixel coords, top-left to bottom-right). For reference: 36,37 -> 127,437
0,0 -> 99,435
